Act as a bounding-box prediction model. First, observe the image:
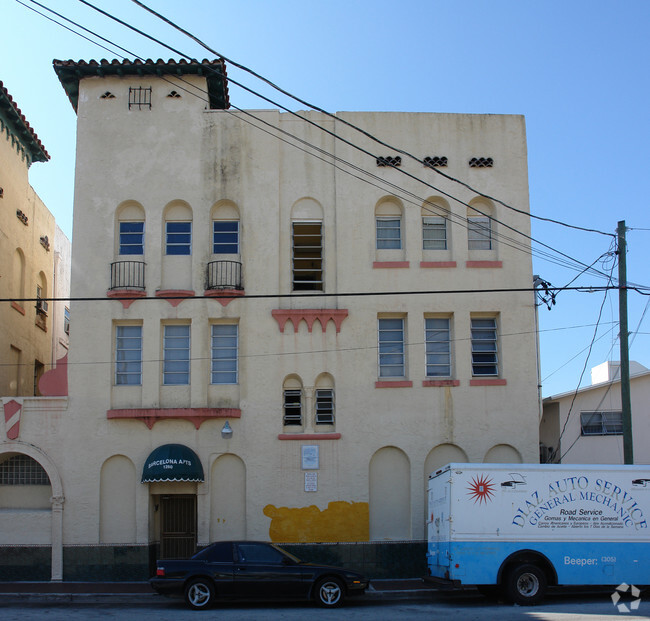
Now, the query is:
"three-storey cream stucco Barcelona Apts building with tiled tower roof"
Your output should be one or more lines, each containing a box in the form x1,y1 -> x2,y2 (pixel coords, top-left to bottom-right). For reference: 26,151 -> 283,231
0,61 -> 540,579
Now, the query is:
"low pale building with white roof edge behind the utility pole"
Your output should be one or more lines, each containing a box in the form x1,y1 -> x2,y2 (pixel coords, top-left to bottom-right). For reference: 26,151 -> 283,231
539,361 -> 650,464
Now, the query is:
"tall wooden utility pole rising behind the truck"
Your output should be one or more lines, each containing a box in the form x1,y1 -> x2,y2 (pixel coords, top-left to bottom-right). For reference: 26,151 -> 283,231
617,220 -> 634,464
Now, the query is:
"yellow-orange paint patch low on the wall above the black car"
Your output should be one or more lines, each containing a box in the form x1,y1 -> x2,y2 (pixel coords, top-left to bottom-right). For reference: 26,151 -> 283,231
264,501 -> 370,543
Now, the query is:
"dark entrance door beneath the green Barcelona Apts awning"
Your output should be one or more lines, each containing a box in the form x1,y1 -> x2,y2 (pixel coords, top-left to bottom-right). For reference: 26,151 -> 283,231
160,494 -> 196,558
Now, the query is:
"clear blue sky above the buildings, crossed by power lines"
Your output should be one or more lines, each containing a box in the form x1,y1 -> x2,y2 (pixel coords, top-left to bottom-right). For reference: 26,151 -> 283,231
0,0 -> 650,394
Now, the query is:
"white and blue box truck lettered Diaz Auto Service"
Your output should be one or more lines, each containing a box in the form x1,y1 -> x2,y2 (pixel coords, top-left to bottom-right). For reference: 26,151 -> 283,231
427,463 -> 650,604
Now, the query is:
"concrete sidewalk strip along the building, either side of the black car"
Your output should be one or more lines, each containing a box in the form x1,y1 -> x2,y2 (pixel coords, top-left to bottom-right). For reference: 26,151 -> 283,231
0,578 -> 438,605
